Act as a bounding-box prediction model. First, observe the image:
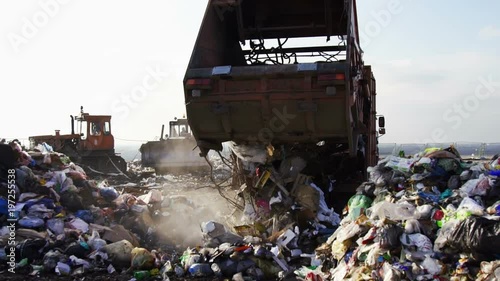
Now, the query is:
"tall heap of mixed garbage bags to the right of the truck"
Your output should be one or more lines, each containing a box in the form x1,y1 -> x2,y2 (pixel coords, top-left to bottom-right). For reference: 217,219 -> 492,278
312,147 -> 500,280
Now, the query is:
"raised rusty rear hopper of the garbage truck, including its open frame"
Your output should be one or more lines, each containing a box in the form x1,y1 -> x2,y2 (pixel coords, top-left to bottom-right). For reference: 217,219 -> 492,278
184,0 -> 362,152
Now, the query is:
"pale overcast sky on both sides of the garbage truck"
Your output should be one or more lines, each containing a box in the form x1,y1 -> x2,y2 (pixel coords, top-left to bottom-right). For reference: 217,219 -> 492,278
0,0 -> 500,148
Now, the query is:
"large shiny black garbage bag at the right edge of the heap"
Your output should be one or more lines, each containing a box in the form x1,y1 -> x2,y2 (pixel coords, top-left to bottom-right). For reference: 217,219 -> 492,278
447,217 -> 500,257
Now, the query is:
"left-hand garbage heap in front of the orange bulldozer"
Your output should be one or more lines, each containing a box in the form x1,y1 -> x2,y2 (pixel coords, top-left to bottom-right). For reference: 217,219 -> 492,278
0,142 -> 234,280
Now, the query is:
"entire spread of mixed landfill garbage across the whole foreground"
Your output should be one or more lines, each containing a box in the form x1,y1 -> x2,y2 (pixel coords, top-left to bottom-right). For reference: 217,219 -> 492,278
0,138 -> 500,280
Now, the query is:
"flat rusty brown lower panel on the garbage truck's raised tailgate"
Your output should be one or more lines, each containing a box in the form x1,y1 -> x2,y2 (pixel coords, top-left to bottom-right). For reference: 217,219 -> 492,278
187,85 -> 346,143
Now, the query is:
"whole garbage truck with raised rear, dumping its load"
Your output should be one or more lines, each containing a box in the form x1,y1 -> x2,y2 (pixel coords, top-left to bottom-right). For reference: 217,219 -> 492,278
183,0 -> 385,195
